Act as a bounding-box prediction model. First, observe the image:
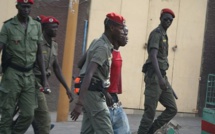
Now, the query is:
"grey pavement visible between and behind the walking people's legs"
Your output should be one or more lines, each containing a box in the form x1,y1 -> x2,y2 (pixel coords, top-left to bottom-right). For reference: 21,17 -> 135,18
25,110 -> 201,134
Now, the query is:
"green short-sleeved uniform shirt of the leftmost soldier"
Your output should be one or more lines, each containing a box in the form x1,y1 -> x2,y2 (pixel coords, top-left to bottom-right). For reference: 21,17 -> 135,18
0,16 -> 43,67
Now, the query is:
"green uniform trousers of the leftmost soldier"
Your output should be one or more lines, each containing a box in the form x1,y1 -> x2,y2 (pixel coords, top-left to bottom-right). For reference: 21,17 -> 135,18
0,67 -> 36,134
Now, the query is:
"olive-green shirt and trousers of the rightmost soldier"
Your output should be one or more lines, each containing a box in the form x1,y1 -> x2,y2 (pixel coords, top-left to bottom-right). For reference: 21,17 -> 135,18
138,26 -> 177,134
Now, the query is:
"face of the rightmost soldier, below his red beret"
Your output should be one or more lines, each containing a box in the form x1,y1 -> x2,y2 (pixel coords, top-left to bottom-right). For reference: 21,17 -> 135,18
160,13 -> 173,30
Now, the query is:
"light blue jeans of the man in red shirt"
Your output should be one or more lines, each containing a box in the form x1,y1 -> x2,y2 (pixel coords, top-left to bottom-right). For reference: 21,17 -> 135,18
109,106 -> 131,134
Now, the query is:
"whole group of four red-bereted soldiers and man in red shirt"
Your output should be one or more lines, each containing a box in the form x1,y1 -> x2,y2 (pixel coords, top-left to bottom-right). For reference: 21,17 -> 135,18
0,0 -> 177,134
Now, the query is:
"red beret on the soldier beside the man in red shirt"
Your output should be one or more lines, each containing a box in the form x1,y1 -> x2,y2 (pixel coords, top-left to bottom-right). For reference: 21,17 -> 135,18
106,12 -> 125,25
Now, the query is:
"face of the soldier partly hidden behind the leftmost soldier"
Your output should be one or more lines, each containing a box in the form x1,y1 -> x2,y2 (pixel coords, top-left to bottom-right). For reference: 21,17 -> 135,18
44,23 -> 58,37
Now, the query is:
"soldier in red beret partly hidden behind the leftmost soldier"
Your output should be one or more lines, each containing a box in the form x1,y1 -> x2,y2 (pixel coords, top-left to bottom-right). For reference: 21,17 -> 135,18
32,15 -> 73,134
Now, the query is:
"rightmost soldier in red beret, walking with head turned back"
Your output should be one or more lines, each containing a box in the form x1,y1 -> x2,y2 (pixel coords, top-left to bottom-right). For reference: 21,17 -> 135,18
138,8 -> 177,134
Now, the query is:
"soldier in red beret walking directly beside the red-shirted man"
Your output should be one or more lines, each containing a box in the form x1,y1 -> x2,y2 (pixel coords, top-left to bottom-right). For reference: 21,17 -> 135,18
71,12 -> 125,134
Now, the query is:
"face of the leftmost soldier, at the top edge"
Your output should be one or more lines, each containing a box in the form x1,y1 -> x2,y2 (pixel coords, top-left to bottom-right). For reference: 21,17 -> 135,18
16,3 -> 31,18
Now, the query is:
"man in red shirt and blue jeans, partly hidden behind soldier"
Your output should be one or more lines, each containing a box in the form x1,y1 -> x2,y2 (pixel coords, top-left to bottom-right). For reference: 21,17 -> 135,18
108,26 -> 131,134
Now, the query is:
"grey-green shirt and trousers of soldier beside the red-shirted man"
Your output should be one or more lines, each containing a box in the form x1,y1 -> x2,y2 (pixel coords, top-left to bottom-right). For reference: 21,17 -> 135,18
80,34 -> 113,134
